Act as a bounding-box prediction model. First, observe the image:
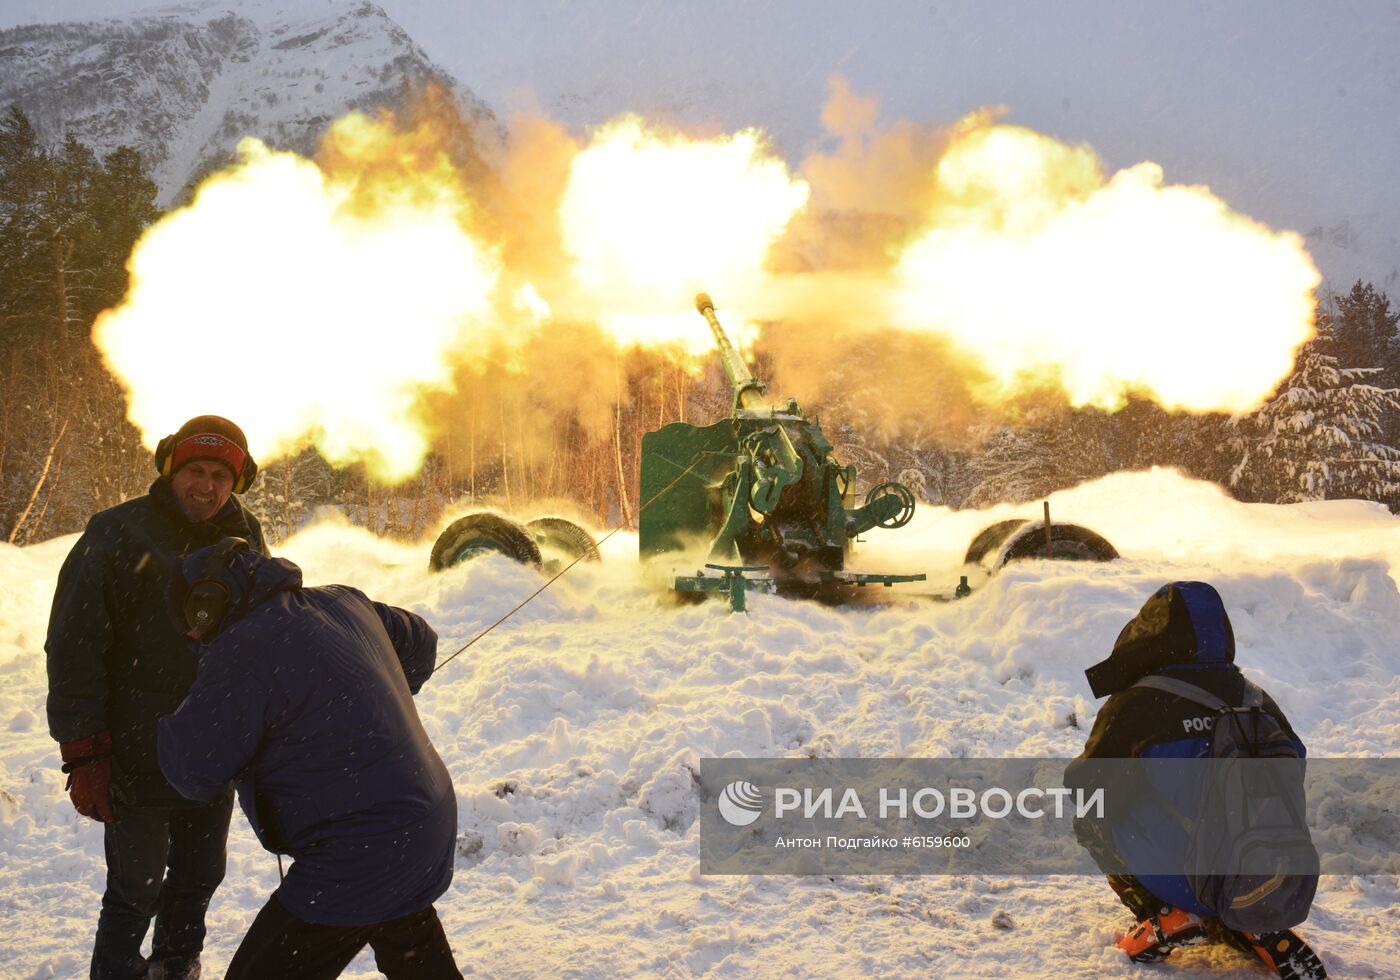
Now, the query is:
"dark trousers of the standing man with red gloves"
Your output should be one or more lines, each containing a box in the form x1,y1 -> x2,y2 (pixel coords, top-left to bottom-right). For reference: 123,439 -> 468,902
90,795 -> 234,980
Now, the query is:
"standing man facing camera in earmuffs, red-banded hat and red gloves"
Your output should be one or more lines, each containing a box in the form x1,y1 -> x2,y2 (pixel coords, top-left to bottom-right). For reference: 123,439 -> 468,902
45,416 -> 266,980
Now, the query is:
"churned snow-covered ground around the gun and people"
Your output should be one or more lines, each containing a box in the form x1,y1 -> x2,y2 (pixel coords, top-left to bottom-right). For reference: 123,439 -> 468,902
0,472 -> 1400,977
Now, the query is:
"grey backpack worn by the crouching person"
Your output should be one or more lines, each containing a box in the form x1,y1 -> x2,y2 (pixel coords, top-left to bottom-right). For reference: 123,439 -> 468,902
1134,675 -> 1319,932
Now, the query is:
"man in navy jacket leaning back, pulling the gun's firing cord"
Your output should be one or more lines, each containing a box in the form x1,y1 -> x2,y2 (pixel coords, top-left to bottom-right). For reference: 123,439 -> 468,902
158,538 -> 462,980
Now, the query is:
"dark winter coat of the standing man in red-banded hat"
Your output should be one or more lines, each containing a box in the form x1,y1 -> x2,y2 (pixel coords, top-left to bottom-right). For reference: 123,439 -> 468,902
45,477 -> 267,806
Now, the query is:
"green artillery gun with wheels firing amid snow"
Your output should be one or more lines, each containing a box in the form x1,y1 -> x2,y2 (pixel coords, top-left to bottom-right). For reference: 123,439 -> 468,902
430,293 -> 1119,609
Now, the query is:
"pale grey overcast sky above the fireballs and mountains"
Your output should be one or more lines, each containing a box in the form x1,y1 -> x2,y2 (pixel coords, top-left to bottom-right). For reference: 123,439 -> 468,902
0,0 -> 1400,282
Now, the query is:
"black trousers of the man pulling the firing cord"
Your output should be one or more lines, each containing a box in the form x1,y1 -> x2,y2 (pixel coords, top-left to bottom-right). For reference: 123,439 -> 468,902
224,892 -> 462,980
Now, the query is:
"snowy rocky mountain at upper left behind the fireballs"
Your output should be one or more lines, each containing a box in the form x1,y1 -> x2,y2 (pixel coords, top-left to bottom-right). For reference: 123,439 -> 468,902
0,0 -> 491,204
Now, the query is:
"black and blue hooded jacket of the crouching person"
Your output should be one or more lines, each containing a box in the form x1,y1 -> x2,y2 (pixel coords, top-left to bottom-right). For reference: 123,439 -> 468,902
1065,582 -> 1303,916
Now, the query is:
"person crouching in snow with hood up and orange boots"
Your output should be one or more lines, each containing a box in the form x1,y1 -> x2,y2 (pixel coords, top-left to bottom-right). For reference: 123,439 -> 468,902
1065,582 -> 1327,980
